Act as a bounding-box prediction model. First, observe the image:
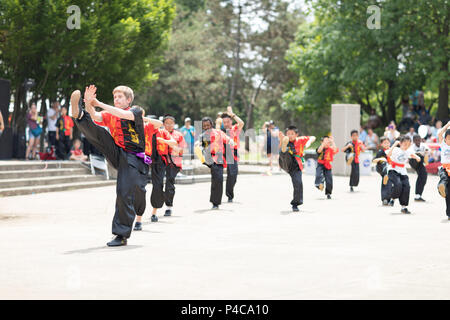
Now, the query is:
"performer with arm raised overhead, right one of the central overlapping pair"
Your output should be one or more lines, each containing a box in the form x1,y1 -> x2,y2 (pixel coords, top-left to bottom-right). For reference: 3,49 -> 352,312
216,106 -> 245,202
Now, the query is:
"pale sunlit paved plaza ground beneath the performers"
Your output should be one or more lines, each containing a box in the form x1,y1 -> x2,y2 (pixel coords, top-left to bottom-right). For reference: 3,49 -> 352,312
0,174 -> 450,299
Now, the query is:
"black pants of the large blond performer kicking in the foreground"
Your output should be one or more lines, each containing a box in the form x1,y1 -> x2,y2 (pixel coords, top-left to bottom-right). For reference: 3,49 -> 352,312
75,112 -> 148,238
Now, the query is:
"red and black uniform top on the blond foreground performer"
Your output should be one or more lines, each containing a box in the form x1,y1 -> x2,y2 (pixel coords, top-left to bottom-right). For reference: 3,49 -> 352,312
95,108 -> 146,153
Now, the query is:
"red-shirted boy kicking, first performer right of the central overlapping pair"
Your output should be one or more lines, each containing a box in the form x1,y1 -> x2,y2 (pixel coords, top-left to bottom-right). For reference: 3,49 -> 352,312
278,126 -> 316,212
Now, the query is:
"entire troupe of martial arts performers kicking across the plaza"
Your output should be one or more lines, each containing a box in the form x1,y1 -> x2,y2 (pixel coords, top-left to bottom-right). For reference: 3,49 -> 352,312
70,85 -> 450,246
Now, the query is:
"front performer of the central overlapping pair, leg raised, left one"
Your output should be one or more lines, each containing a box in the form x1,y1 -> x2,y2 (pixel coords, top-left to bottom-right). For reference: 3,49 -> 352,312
195,117 -> 234,210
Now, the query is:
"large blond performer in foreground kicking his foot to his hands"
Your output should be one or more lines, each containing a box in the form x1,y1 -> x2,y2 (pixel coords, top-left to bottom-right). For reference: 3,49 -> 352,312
70,86 -> 149,247
